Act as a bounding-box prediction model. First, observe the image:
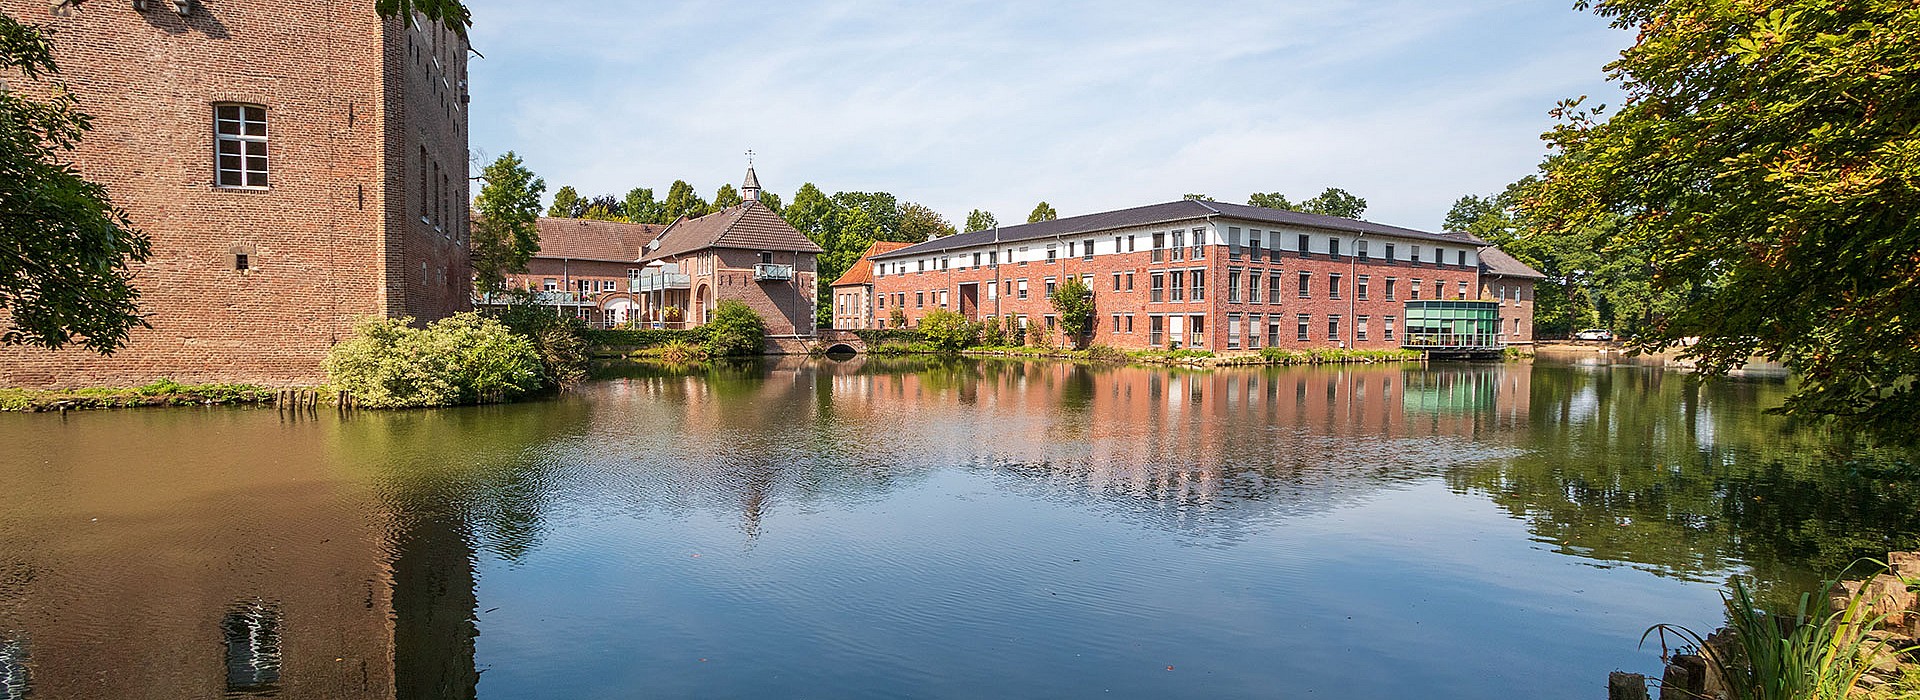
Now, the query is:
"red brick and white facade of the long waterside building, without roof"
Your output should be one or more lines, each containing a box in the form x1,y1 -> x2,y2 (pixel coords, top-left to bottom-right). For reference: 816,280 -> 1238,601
874,205 -> 1484,351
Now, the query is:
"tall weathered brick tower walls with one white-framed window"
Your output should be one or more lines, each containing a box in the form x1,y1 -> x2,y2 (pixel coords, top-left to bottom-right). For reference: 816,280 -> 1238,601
0,0 -> 470,387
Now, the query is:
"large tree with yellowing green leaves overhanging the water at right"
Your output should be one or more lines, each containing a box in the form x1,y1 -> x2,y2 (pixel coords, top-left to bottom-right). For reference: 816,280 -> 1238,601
1524,0 -> 1920,441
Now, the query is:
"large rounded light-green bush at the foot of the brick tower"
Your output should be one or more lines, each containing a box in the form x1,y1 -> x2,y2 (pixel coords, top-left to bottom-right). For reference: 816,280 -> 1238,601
326,313 -> 545,408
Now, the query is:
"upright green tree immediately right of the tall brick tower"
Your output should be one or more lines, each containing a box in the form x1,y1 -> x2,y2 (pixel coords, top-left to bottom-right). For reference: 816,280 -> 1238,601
472,152 -> 547,293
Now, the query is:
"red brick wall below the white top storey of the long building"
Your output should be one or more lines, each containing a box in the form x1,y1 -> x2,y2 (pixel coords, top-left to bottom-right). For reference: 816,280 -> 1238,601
874,234 -> 1478,351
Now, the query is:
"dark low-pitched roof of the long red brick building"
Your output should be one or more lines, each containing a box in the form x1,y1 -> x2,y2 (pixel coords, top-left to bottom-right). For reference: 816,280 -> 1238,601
876,199 -> 1486,259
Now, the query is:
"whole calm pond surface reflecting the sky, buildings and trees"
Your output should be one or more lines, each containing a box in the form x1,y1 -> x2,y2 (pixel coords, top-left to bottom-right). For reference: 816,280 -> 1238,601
0,359 -> 1920,700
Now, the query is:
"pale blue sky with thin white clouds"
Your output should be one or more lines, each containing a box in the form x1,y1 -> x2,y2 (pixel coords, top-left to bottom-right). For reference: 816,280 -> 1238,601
468,0 -> 1632,230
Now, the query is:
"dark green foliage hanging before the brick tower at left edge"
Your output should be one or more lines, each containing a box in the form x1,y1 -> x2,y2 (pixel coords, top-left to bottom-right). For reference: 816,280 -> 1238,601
0,13 -> 150,355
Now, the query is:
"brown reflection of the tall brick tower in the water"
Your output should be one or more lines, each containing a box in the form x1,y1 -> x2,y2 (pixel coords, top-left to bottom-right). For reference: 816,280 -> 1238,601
0,410 -> 478,700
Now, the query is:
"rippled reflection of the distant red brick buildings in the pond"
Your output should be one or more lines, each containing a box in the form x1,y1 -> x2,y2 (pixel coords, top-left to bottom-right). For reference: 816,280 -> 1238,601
599,357 -> 1530,533
